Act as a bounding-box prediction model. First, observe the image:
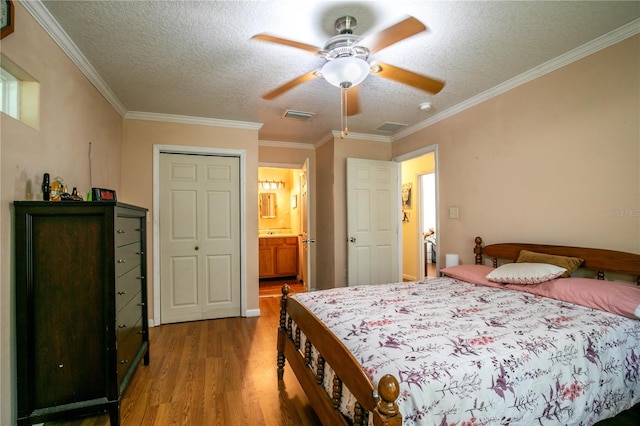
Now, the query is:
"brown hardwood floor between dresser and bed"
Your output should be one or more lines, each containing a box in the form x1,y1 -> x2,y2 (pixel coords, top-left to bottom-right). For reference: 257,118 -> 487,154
46,290 -> 640,426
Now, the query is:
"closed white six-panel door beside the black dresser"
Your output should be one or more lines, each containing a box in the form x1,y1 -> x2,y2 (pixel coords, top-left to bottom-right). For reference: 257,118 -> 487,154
159,154 -> 240,323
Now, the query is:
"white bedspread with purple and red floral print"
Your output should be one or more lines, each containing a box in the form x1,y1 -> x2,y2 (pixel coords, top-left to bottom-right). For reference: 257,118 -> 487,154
293,277 -> 640,426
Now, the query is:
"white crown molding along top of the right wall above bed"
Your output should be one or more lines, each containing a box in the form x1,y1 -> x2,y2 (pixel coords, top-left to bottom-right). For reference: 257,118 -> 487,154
392,19 -> 640,141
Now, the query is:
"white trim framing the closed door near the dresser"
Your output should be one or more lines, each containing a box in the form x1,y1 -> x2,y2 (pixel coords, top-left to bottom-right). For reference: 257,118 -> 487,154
152,145 -> 248,326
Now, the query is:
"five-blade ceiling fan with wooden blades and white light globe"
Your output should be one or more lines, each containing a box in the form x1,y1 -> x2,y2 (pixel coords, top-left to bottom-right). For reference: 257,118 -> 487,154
252,16 -> 445,134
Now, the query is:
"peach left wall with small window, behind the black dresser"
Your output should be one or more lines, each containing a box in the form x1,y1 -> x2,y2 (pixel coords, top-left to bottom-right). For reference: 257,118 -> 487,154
0,2 -> 122,425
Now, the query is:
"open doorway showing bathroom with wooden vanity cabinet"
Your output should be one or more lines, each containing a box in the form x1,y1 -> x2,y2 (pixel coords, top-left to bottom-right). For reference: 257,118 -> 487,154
258,166 -> 307,297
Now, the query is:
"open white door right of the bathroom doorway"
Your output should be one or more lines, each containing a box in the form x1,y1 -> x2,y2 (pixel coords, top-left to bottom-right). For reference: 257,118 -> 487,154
347,158 -> 400,286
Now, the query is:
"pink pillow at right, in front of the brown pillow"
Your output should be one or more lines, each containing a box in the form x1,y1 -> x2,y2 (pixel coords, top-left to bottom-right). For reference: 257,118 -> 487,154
507,277 -> 640,319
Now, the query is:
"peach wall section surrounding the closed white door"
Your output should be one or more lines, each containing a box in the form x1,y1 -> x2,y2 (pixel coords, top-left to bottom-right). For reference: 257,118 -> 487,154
122,119 -> 258,318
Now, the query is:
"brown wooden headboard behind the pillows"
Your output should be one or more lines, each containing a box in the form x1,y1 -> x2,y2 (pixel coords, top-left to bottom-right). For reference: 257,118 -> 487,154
473,237 -> 640,285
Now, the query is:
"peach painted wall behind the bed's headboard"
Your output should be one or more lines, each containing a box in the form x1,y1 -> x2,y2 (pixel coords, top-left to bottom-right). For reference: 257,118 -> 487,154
393,35 -> 640,264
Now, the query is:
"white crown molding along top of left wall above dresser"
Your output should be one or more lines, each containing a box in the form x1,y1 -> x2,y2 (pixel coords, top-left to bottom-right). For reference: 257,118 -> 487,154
20,0 -> 127,117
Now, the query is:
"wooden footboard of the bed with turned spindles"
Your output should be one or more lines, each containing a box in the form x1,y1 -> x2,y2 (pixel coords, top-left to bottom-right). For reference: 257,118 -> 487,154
278,284 -> 402,426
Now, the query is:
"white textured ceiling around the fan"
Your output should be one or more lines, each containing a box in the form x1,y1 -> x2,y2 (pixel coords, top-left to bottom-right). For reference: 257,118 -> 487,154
32,0 -> 640,143
